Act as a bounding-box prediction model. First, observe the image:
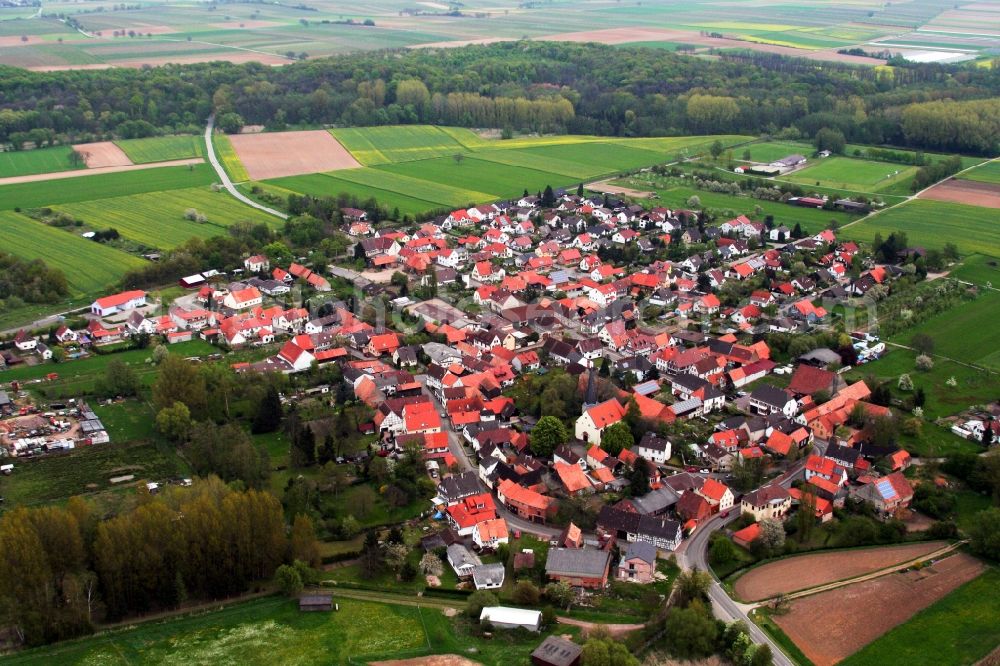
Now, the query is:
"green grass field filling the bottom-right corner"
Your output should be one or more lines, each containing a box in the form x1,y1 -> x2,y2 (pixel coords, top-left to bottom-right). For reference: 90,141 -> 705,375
840,568 -> 1000,666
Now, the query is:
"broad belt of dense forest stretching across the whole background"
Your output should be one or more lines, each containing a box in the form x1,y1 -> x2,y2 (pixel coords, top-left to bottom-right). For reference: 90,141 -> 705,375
0,42 -> 1000,154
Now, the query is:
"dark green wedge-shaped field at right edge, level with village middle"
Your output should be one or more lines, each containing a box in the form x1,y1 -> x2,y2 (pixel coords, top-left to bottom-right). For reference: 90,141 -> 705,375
893,289 -> 1000,370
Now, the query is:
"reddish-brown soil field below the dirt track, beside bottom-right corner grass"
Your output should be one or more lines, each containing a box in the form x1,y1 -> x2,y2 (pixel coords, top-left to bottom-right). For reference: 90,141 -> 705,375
773,554 -> 984,666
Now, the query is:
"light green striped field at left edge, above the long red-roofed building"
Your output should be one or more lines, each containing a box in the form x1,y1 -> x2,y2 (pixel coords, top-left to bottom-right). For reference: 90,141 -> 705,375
0,211 -> 146,294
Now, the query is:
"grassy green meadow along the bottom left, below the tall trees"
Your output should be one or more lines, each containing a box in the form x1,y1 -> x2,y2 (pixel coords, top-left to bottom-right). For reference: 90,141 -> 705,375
5,596 -> 560,666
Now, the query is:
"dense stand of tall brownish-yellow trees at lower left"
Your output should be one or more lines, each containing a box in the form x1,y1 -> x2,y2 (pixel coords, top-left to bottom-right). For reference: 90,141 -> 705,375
0,477 -> 317,645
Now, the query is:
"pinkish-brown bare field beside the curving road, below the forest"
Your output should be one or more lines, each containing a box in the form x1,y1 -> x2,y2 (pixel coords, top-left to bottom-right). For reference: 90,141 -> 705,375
229,130 -> 361,180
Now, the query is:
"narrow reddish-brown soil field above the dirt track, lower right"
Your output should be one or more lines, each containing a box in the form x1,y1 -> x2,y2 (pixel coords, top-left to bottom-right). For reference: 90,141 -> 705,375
734,541 -> 944,601
